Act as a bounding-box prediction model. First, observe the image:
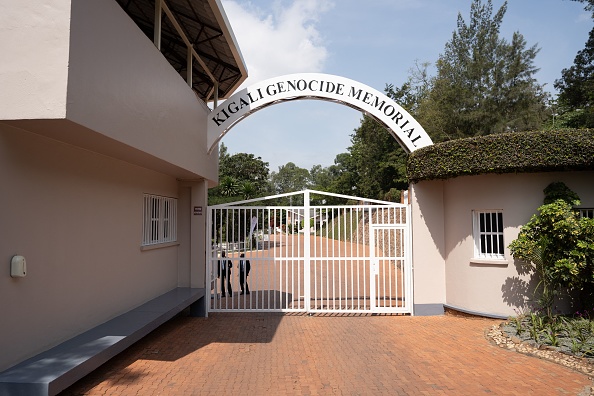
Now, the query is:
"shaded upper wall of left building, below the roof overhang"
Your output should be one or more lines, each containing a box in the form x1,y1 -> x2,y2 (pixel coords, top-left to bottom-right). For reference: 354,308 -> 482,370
67,0 -> 218,180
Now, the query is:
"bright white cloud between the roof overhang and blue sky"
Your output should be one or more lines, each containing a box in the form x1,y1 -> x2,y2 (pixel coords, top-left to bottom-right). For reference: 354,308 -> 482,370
223,0 -> 333,86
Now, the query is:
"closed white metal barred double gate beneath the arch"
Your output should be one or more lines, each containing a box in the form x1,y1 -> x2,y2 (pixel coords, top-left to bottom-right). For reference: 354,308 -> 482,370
208,190 -> 412,313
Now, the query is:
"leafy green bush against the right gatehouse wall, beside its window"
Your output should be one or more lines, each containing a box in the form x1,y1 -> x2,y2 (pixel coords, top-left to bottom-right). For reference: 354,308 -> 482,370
509,183 -> 594,316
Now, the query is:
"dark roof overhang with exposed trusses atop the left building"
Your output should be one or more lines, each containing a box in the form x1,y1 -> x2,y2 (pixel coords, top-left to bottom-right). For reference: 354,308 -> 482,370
117,0 -> 247,102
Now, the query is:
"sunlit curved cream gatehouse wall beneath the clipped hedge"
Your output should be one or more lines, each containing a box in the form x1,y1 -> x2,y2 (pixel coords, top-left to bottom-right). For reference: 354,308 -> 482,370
426,172 -> 594,317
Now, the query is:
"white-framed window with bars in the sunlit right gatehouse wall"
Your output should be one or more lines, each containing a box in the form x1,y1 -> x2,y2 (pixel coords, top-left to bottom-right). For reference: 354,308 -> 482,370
472,209 -> 505,260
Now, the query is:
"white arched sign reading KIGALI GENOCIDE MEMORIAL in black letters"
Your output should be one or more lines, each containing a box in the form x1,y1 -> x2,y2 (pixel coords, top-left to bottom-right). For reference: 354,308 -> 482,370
207,73 -> 433,153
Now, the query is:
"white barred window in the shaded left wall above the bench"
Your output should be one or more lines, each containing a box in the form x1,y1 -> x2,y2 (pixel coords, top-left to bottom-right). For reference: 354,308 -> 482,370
142,194 -> 177,246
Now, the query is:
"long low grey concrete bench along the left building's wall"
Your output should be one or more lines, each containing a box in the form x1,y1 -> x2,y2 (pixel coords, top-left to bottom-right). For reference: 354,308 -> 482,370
0,287 -> 205,396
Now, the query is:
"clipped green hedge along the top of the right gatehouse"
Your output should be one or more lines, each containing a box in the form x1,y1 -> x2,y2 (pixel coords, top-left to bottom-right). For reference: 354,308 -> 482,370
407,129 -> 594,183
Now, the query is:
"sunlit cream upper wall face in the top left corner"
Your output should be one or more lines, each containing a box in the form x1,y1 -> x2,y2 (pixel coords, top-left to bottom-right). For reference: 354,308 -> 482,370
0,0 -> 70,120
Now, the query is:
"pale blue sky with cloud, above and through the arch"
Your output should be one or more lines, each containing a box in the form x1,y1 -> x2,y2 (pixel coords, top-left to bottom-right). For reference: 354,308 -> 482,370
222,0 -> 592,171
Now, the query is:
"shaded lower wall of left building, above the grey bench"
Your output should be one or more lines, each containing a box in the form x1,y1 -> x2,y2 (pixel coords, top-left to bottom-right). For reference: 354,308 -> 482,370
0,124 -> 187,371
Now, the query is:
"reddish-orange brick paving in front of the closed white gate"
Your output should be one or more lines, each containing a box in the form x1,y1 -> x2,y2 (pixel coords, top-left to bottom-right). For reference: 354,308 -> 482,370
63,313 -> 592,395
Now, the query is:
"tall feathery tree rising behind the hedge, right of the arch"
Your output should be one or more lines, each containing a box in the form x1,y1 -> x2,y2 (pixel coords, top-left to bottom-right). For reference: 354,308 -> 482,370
400,0 -> 548,141
